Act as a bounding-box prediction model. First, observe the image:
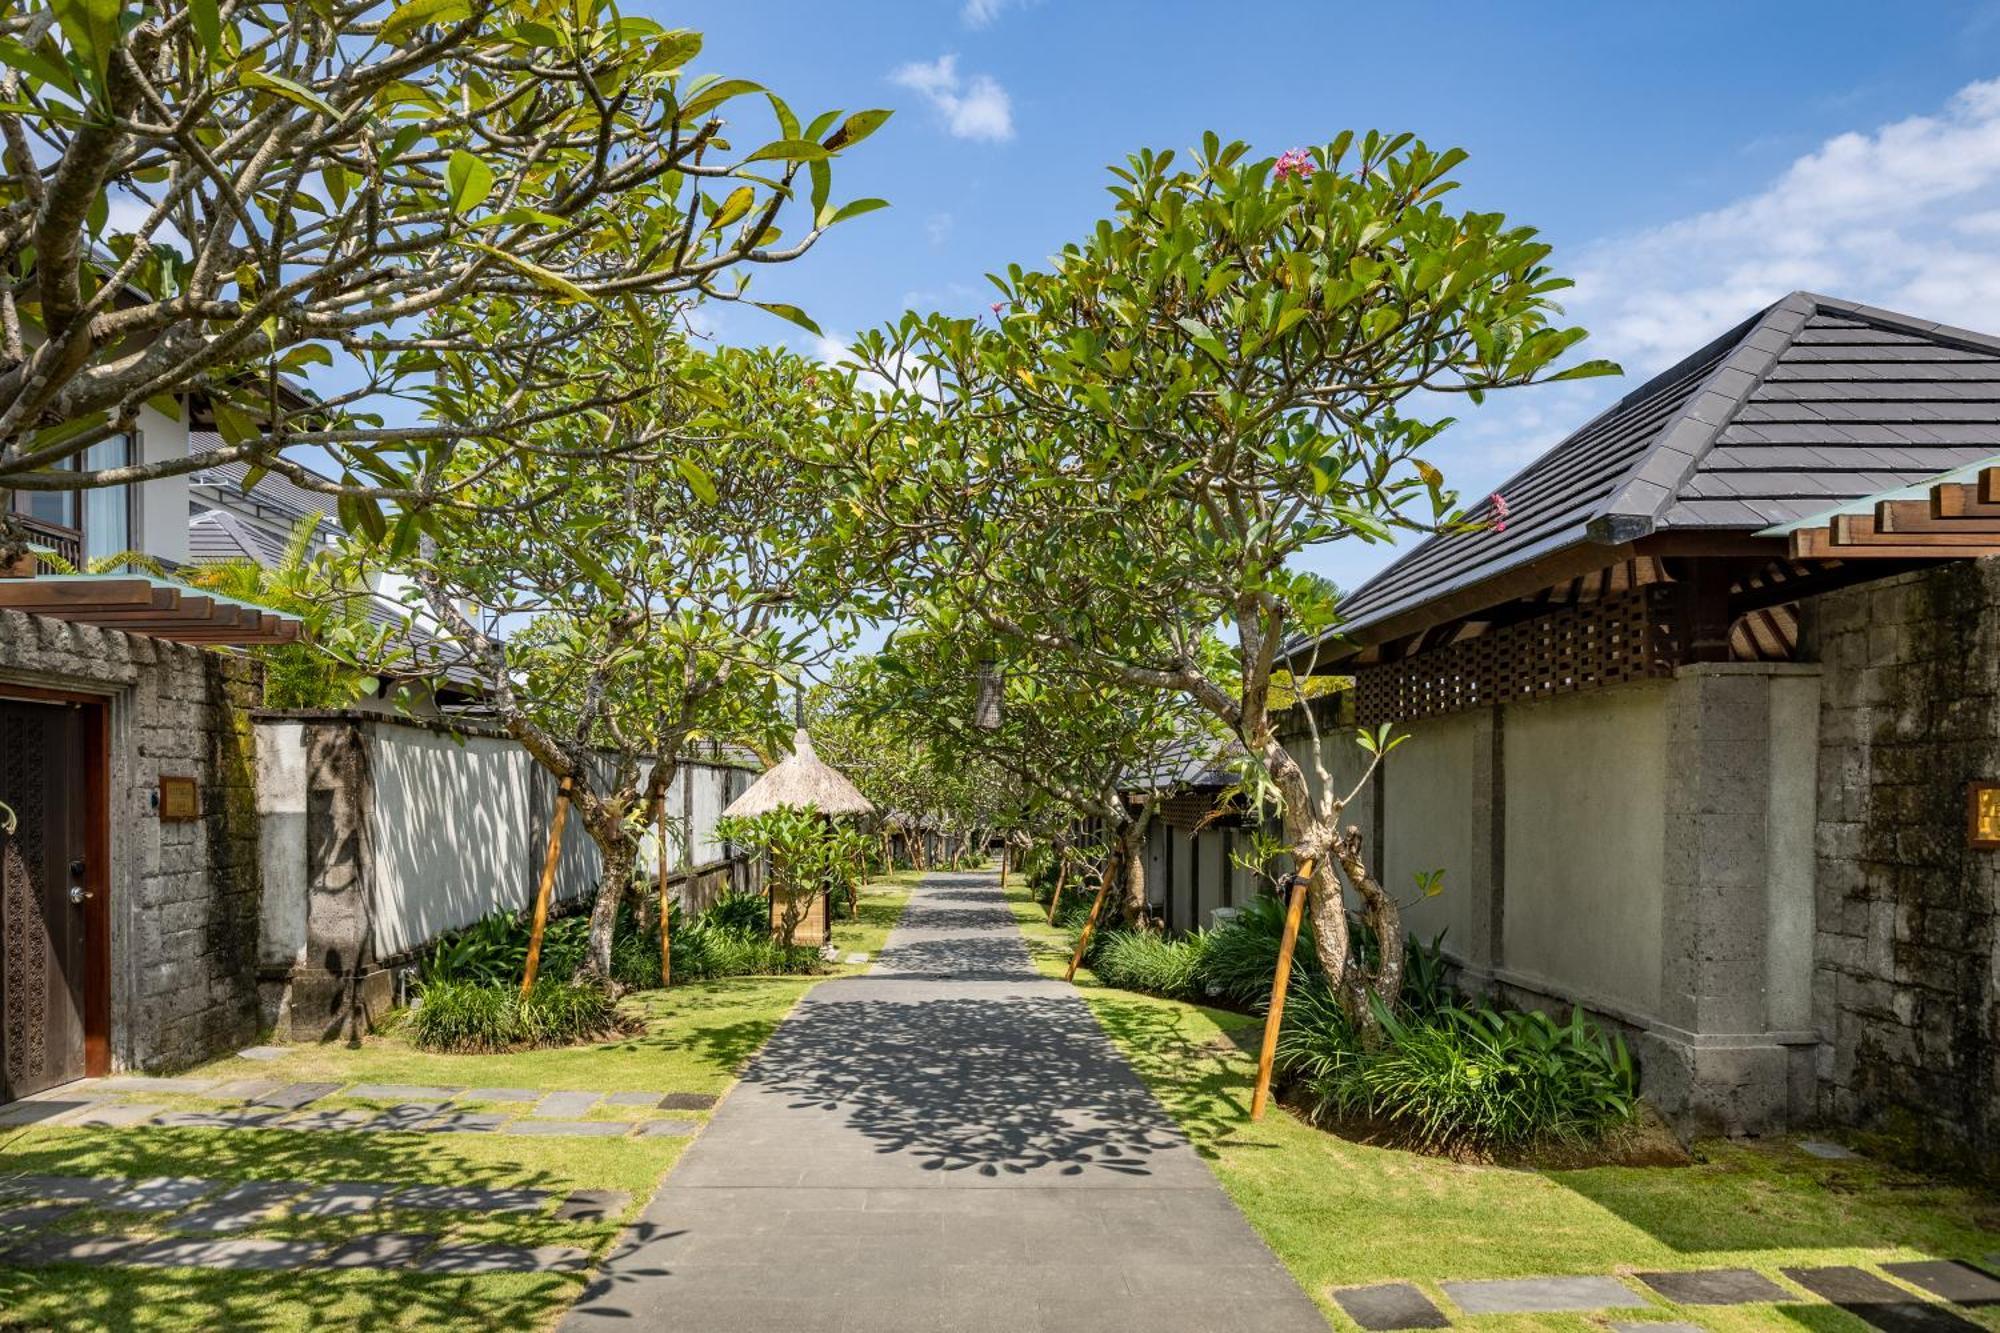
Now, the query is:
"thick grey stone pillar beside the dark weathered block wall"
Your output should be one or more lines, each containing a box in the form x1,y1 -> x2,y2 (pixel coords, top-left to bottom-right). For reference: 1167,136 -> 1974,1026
1642,662 -> 1818,1133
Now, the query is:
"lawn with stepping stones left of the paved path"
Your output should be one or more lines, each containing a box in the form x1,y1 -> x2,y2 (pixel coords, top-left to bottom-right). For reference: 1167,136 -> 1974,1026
0,873 -> 918,1333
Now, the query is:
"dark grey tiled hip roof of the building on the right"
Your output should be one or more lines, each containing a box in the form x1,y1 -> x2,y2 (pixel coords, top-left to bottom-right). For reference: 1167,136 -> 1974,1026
1304,292 -> 2000,640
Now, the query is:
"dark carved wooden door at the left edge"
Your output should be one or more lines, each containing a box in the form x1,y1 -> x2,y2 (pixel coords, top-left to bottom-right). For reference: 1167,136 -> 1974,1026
0,699 -> 100,1101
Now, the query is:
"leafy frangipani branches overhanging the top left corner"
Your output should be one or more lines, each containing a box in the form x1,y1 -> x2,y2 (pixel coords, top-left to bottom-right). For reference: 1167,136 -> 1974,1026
0,0 -> 888,536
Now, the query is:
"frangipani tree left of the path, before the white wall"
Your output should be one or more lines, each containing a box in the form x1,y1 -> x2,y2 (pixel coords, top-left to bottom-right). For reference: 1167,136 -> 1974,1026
368,334 -> 842,975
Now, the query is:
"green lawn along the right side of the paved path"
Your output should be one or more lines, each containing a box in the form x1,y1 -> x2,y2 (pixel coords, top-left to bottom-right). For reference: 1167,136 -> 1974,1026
1012,876 -> 2000,1333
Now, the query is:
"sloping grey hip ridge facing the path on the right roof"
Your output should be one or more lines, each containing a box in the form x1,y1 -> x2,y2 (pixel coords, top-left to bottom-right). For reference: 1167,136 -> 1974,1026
1584,290 -> 1824,546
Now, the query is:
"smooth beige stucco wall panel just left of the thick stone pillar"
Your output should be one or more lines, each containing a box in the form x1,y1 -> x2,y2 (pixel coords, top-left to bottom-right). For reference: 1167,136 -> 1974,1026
1504,683 -> 1670,1013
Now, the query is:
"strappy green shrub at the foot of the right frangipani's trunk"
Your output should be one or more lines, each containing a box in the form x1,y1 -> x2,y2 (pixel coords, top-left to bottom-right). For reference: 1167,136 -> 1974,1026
1292,992 -> 1638,1149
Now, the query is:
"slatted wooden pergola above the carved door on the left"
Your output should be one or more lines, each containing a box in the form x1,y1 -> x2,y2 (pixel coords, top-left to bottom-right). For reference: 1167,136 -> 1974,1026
0,574 -> 302,646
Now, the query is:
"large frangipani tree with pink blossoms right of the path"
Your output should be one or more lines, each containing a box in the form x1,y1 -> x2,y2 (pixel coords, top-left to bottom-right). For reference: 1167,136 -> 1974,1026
830,132 -> 1614,1023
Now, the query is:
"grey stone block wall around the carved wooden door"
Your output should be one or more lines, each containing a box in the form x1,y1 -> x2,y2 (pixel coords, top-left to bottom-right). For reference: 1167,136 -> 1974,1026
0,610 -> 260,1069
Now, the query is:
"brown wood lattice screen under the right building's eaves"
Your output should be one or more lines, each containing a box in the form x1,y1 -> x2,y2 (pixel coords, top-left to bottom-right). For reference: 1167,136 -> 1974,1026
1354,582 -> 1680,727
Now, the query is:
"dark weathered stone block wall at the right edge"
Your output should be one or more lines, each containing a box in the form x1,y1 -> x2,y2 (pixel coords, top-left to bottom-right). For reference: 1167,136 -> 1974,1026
1806,560 -> 2000,1155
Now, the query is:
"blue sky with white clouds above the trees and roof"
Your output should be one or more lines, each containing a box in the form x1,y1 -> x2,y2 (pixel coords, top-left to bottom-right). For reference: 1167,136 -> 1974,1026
676,0 -> 2000,586
